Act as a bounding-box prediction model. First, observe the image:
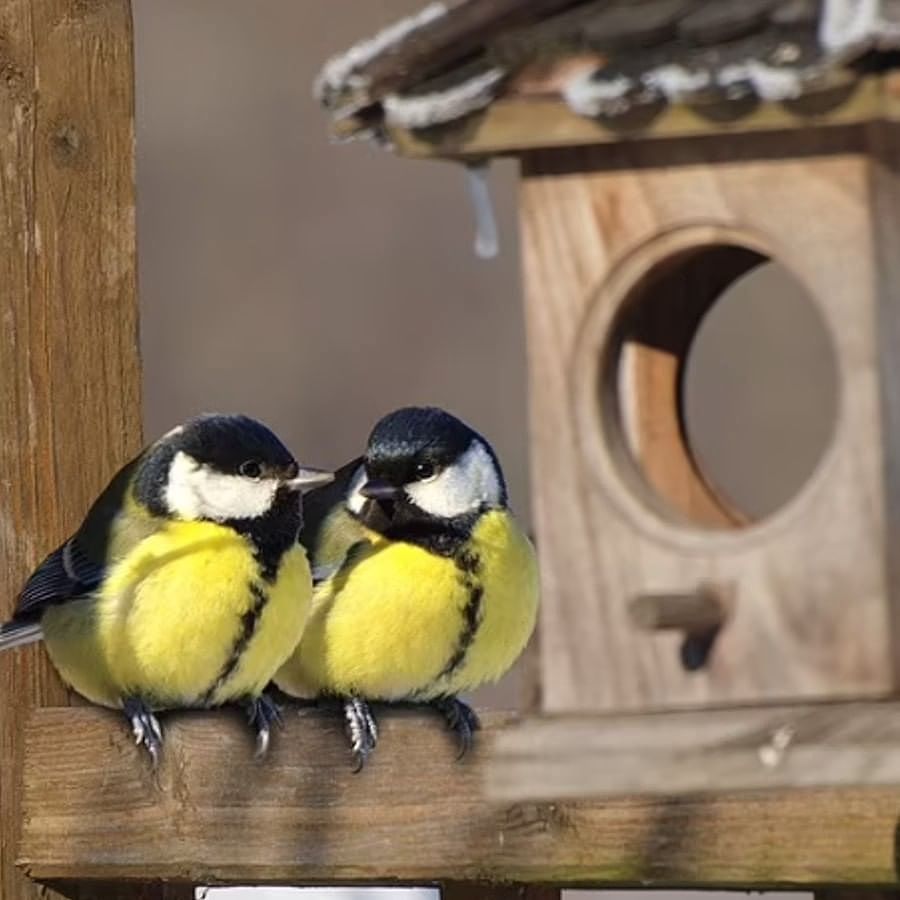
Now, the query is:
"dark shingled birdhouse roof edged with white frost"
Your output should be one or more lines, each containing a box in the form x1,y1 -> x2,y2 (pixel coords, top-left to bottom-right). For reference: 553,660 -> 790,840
315,0 -> 900,152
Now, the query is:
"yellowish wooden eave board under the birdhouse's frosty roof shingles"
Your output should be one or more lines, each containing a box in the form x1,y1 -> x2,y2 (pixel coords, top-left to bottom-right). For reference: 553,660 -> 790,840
374,75 -> 900,159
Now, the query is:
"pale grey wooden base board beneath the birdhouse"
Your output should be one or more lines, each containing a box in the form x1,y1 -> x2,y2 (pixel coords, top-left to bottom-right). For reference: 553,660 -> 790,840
485,703 -> 900,802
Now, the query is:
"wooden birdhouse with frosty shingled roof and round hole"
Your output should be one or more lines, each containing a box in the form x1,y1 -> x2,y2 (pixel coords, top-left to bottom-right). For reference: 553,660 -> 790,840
317,0 -> 900,732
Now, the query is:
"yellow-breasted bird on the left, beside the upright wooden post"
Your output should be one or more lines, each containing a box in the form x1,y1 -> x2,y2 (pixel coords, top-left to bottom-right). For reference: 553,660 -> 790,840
0,414 -> 333,767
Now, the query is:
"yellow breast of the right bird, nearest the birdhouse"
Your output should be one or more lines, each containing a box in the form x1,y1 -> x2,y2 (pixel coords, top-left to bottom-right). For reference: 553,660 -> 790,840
276,511 -> 538,700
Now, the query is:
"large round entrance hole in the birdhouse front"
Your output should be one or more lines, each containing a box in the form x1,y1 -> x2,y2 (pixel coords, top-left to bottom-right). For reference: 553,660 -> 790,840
594,243 -> 838,529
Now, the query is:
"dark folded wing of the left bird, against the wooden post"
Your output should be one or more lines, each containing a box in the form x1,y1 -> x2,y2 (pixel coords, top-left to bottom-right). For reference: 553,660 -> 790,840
13,457 -> 140,620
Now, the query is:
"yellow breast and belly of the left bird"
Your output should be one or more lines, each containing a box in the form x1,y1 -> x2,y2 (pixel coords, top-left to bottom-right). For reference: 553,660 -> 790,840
45,523 -> 311,707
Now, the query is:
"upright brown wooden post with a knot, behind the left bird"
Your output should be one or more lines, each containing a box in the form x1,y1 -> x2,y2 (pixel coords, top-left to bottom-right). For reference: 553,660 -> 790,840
0,0 -> 141,900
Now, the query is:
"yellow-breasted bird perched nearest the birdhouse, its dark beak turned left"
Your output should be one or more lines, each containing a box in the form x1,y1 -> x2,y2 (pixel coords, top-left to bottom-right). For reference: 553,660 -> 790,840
274,407 -> 540,771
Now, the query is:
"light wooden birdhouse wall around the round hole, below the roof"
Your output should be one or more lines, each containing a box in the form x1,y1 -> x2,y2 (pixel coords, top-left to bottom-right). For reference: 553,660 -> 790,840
521,129 -> 900,711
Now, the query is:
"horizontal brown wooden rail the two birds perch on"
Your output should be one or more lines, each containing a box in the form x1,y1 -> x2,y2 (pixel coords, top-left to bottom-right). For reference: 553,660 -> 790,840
20,708 -> 900,889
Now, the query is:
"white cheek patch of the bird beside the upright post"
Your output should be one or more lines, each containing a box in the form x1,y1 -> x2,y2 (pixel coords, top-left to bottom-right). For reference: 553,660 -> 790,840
165,452 -> 278,522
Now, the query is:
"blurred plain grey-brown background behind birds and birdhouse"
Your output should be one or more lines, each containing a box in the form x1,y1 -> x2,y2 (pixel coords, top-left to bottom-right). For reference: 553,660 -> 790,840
134,0 -> 835,900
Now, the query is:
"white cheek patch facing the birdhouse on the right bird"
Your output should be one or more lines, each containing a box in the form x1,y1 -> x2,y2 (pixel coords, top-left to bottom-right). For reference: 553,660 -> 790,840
404,441 -> 502,519
